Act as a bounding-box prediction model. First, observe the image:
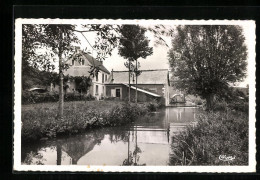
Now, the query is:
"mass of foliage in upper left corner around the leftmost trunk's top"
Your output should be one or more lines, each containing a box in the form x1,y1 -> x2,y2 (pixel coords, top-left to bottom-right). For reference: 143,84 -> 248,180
22,24 -> 79,71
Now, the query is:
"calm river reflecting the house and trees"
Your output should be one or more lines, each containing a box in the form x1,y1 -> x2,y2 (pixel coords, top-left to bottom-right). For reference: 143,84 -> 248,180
22,107 -> 197,166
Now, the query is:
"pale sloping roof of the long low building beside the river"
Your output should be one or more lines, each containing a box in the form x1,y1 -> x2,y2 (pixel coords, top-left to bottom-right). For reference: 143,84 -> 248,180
106,69 -> 169,84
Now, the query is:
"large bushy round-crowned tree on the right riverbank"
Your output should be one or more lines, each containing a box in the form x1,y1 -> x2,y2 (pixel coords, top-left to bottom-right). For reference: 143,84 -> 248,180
168,25 -> 247,109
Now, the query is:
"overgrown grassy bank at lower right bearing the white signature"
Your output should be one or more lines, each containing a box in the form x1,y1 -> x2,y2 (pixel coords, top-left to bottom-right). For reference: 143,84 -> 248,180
170,107 -> 249,165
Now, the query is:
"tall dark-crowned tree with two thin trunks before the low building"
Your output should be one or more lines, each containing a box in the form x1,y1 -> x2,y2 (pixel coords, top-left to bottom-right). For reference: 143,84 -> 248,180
119,25 -> 153,102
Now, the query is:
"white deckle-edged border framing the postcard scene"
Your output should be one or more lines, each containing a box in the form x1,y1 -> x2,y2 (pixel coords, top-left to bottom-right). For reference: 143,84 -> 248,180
13,18 -> 256,173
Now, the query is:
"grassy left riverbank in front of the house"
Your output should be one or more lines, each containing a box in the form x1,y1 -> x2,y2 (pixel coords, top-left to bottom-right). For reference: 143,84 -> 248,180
22,101 -> 158,142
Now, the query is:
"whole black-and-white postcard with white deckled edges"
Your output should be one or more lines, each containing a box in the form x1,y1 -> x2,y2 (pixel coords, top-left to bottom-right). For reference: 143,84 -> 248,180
13,18 -> 256,173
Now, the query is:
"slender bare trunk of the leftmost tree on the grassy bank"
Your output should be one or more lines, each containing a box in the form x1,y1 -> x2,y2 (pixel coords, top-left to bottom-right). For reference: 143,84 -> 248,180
59,53 -> 64,120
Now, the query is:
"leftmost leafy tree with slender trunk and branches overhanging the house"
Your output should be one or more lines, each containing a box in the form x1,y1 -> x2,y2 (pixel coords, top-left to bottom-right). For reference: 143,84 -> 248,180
22,24 -> 117,119
